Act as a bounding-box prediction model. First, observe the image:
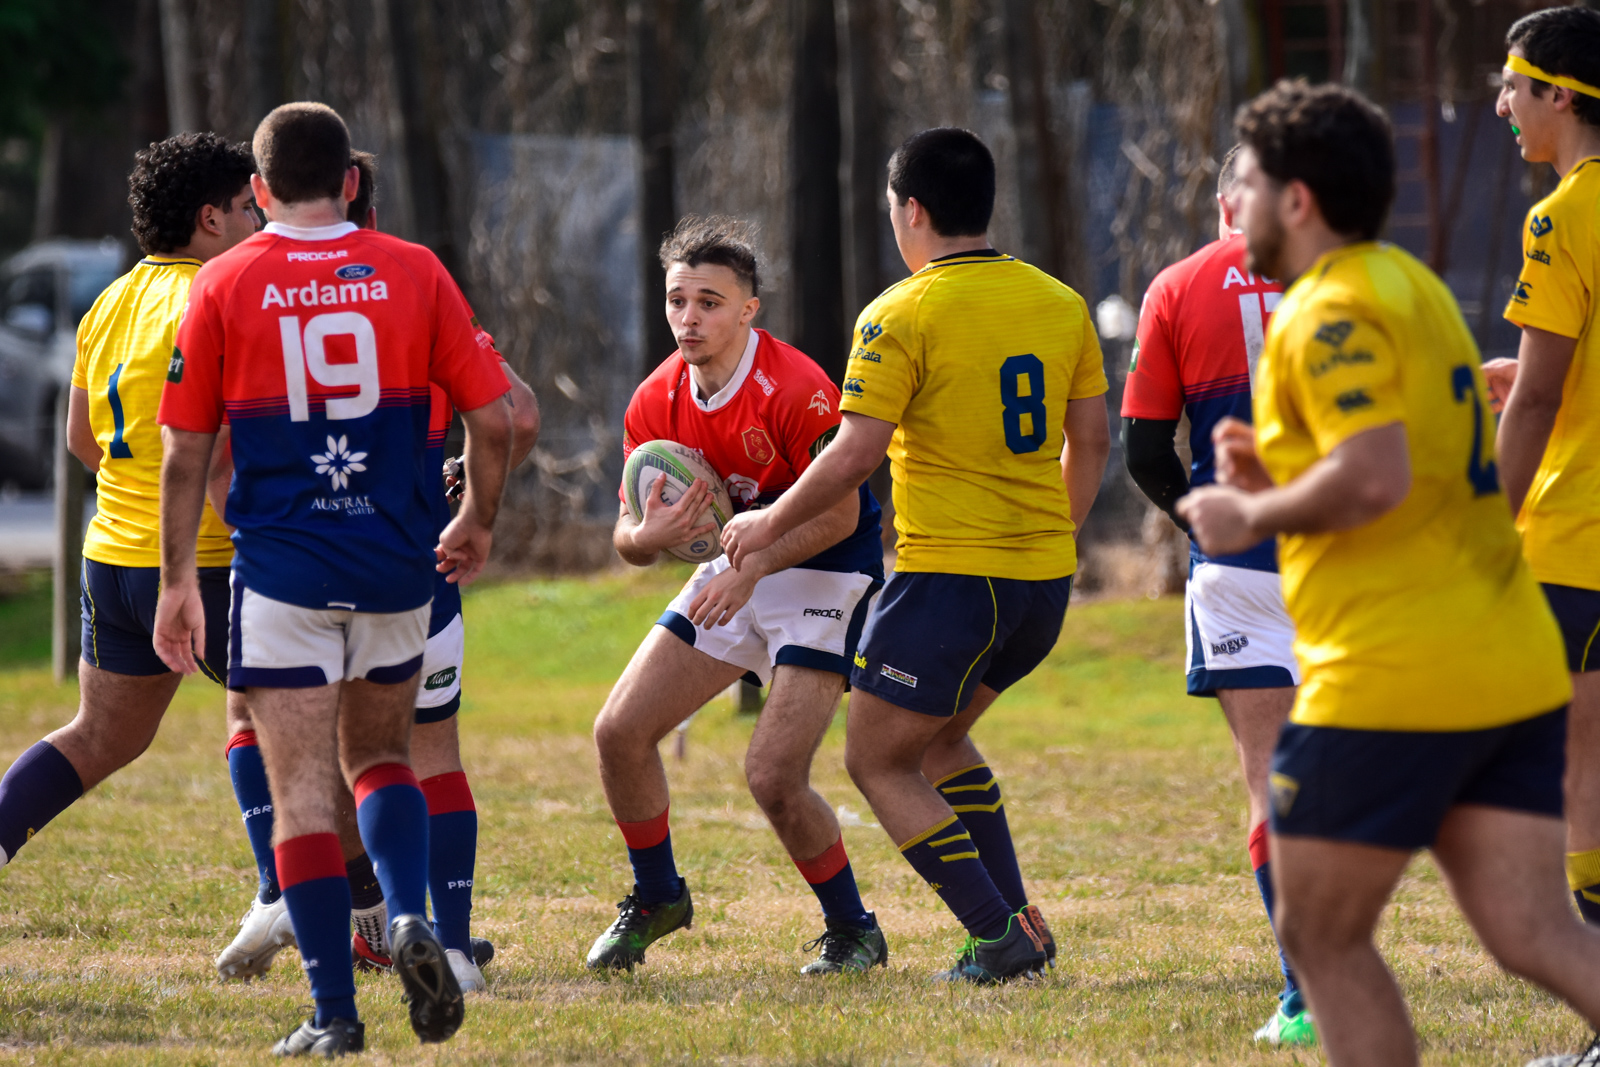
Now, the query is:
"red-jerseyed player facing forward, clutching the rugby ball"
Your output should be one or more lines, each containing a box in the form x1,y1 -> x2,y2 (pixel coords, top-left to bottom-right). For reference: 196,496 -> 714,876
589,218 -> 888,974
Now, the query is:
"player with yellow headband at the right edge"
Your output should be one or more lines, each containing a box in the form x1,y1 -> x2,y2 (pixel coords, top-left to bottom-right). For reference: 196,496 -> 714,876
1483,8 -> 1600,947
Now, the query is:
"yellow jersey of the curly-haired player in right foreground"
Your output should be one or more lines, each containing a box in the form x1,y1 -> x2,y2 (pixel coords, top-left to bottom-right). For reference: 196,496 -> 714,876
1254,242 -> 1571,731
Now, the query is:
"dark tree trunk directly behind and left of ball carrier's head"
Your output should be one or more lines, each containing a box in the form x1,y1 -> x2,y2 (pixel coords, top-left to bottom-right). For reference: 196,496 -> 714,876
627,0 -> 678,378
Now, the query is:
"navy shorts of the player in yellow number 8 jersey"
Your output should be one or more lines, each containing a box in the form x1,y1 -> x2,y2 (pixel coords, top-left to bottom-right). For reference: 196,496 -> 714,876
850,571 -> 1072,718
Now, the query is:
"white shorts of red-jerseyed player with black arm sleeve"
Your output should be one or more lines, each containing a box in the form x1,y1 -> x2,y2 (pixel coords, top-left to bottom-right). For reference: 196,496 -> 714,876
1184,561 -> 1299,696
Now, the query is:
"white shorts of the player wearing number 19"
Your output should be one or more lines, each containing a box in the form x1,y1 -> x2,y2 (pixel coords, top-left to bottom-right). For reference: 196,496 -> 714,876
227,573 -> 429,689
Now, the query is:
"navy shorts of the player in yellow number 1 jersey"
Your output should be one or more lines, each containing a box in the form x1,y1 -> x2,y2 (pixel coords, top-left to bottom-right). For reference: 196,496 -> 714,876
78,560 -> 229,685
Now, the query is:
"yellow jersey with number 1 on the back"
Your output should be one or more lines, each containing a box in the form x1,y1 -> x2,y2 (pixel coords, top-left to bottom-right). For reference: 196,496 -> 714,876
72,256 -> 234,566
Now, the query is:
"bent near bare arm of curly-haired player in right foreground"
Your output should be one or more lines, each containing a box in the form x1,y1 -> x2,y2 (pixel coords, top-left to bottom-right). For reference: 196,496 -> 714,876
1178,422 -> 1411,555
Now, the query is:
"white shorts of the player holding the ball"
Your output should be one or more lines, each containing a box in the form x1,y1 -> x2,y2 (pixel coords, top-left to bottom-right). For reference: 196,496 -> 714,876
656,555 -> 883,685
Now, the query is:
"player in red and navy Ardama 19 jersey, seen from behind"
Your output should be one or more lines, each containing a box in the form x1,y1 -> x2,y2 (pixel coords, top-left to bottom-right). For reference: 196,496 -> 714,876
154,104 -> 510,1056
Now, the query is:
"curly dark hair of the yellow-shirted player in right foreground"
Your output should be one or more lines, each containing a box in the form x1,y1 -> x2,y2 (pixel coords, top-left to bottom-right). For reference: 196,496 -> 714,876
1234,78 -> 1395,240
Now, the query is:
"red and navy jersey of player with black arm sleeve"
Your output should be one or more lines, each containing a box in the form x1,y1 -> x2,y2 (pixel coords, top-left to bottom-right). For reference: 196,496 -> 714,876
1122,234 -> 1283,571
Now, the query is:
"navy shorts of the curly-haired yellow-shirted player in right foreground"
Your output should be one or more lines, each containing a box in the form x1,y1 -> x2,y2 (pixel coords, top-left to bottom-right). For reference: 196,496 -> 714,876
1269,707 -> 1566,851
